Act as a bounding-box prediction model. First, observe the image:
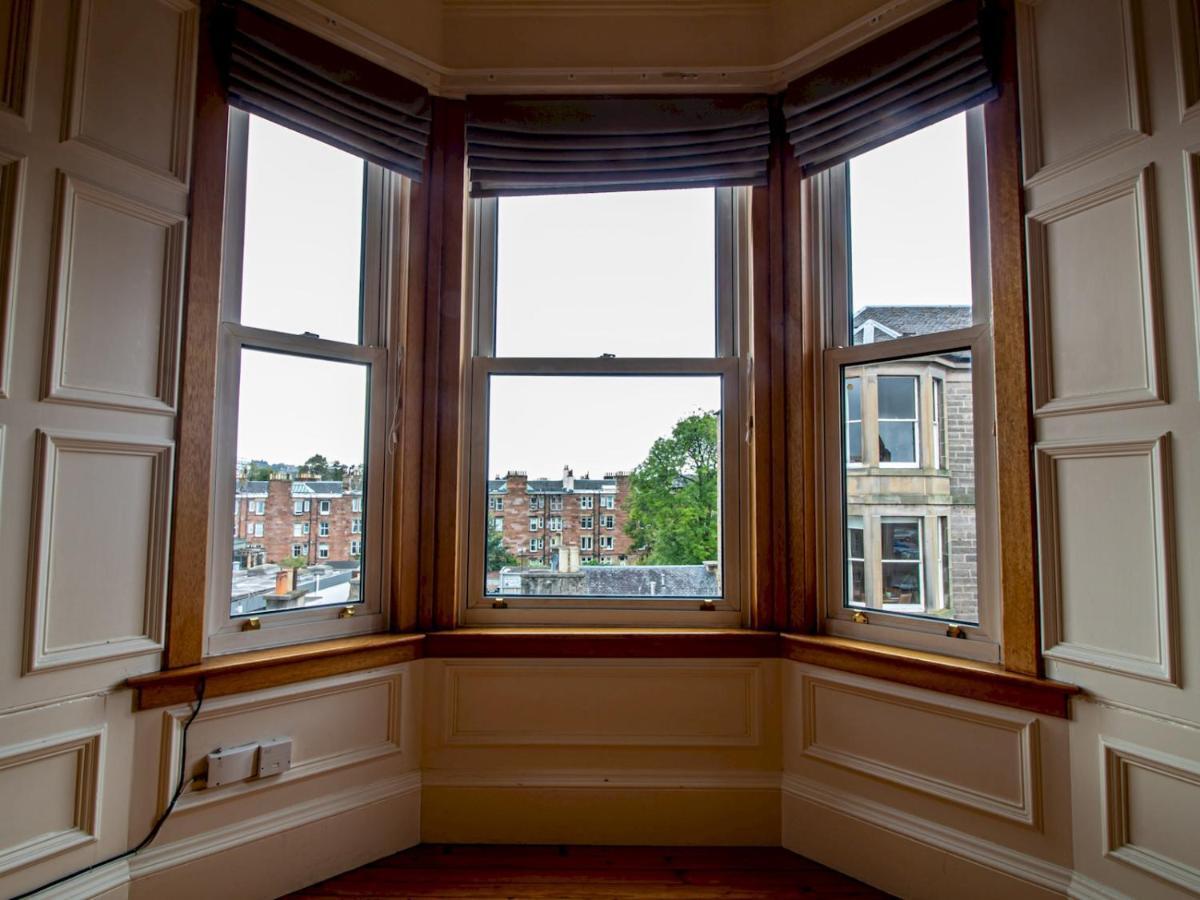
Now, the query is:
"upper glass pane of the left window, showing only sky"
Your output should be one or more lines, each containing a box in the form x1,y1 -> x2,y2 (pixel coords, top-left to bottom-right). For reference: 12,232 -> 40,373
241,115 -> 366,343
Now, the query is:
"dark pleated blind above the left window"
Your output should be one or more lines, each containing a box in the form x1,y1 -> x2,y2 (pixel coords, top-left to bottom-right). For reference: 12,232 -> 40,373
221,2 -> 430,179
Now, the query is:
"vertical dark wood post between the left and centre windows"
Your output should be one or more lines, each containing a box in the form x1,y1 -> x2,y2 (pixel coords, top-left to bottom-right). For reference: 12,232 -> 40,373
414,97 -> 467,630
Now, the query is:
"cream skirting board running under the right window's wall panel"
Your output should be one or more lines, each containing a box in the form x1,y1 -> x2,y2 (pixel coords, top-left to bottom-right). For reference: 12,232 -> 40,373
781,774 -> 1122,900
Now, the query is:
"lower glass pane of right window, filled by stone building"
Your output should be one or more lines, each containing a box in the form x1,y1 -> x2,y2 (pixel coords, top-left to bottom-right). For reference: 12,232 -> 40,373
842,350 -> 979,624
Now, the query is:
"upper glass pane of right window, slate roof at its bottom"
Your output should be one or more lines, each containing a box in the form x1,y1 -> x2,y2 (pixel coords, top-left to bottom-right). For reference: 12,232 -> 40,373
848,106 -> 972,343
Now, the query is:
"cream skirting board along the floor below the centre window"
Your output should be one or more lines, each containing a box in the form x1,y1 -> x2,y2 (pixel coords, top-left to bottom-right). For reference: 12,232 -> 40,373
421,772 -> 780,846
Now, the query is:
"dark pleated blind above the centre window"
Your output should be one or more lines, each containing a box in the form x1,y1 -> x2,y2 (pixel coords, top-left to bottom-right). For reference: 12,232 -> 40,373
467,95 -> 770,197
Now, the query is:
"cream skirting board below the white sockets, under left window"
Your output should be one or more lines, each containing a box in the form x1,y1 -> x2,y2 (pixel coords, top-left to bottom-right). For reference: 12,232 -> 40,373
23,773 -> 421,900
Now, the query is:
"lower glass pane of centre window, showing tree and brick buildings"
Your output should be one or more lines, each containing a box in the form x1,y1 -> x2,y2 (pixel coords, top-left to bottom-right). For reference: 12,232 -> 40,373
485,376 -> 721,600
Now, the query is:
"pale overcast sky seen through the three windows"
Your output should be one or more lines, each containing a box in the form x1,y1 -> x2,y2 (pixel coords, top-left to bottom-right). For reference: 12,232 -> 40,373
238,115 -> 971,478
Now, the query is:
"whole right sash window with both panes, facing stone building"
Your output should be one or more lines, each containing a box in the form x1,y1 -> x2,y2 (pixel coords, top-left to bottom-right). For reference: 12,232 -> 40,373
814,109 -> 1000,661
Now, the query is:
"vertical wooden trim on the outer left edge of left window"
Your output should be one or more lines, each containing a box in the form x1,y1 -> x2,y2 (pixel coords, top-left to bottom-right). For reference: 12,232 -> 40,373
163,2 -> 229,668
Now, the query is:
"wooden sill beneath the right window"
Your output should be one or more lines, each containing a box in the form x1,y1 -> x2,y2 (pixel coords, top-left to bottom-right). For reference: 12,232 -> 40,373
780,635 -> 1080,719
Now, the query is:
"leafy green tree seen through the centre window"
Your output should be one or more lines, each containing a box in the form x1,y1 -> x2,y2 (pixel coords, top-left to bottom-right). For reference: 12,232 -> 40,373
625,410 -> 720,565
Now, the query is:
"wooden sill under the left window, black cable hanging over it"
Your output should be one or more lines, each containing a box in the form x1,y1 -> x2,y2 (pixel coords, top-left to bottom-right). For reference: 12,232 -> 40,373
126,635 -> 425,709
